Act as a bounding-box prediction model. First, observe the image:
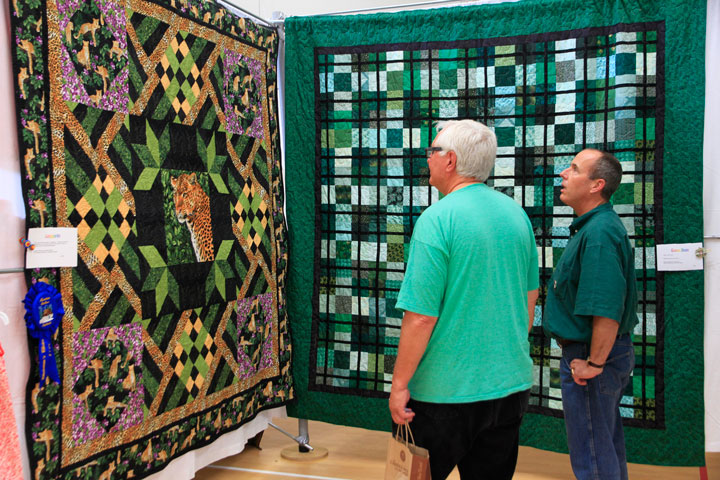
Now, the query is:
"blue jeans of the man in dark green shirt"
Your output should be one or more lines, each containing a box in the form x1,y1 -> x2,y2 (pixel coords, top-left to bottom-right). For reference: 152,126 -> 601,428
560,334 -> 635,480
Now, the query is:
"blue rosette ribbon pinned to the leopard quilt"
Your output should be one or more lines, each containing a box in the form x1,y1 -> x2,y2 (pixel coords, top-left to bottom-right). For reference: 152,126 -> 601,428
23,282 -> 65,387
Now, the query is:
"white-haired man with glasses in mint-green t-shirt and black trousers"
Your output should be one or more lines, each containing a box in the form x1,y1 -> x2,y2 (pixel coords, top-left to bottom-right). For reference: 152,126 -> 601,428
389,120 -> 538,480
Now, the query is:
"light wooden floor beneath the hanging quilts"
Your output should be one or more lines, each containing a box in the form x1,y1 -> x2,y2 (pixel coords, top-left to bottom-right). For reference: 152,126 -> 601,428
195,418 -> 720,480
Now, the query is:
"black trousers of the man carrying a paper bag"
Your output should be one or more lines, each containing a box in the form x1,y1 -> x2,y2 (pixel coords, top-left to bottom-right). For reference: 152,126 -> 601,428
393,390 -> 530,480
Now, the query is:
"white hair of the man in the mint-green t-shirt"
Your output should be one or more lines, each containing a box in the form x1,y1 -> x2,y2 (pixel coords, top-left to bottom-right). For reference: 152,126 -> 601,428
435,120 -> 497,182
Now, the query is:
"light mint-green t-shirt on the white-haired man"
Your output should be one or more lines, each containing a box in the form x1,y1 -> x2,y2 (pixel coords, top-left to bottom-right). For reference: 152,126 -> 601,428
397,184 -> 538,403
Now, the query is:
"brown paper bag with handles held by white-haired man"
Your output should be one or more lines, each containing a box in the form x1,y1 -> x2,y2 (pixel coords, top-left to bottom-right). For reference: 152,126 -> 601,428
385,422 -> 430,480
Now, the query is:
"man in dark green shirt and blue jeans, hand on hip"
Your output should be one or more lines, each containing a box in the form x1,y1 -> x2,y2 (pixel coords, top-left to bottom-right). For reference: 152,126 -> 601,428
543,149 -> 638,480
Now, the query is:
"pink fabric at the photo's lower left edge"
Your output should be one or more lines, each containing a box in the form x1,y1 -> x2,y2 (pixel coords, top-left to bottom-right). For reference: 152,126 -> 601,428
0,346 -> 22,480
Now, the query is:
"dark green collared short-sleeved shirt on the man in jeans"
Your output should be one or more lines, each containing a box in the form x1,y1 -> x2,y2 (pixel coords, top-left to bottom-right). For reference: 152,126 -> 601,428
543,203 -> 638,343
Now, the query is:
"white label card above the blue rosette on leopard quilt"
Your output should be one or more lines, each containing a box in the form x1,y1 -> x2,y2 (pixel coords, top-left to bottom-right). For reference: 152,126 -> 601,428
25,227 -> 77,268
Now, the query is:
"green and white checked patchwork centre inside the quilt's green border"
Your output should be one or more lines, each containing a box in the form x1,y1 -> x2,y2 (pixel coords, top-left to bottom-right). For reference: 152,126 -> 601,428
310,23 -> 663,426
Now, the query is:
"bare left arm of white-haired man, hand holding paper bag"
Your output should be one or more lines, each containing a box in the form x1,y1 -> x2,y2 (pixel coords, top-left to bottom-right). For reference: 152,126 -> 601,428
388,312 -> 437,424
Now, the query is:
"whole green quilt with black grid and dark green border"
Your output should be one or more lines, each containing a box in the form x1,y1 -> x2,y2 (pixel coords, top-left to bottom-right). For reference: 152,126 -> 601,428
286,0 -> 705,465
